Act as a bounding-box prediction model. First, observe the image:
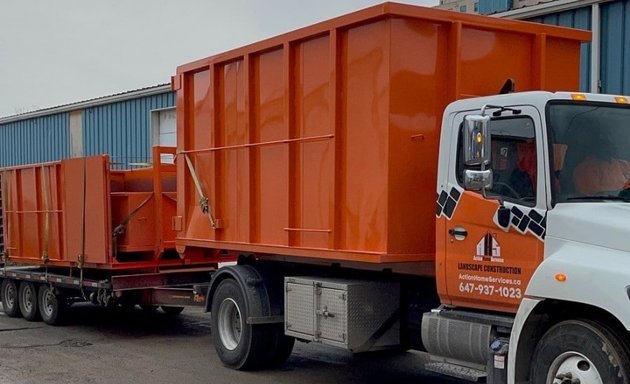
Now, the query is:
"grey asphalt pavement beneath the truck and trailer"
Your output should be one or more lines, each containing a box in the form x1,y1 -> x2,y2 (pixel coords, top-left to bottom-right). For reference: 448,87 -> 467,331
0,304 -> 461,384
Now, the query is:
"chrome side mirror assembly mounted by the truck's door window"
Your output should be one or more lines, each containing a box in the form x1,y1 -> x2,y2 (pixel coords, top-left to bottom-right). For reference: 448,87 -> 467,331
464,115 -> 492,166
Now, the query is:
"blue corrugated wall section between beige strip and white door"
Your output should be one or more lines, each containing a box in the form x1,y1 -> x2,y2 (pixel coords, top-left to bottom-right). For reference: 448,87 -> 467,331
83,92 -> 175,168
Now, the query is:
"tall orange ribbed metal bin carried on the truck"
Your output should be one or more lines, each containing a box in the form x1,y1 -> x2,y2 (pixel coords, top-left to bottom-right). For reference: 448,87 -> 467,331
172,3 -> 589,263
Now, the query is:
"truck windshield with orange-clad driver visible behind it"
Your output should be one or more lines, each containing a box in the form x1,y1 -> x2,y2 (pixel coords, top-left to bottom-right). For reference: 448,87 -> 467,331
547,102 -> 630,203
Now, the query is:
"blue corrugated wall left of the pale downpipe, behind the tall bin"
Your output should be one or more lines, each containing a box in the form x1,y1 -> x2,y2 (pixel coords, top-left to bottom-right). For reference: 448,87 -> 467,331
529,7 -> 592,92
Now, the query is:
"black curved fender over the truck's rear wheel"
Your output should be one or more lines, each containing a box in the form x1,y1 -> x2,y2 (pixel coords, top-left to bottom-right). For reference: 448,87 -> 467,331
205,265 -> 284,324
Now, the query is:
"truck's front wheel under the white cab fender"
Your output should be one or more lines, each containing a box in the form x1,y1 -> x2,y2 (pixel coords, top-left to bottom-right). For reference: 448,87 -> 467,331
530,320 -> 630,384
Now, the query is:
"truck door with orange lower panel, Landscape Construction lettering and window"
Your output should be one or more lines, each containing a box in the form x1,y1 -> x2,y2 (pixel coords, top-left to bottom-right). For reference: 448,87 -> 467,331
437,106 -> 548,312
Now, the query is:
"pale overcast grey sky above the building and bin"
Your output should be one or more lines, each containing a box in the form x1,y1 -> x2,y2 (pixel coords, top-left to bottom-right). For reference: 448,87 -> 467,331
0,0 -> 438,117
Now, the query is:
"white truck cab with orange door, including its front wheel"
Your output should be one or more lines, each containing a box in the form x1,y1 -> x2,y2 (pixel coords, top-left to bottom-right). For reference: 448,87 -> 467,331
436,92 -> 630,383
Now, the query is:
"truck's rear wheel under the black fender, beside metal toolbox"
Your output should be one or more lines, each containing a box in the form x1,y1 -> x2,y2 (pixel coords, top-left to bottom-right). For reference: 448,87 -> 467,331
210,279 -> 273,370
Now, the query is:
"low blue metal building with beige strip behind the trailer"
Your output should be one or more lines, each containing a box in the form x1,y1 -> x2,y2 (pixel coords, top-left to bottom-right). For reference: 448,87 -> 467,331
0,84 -> 176,168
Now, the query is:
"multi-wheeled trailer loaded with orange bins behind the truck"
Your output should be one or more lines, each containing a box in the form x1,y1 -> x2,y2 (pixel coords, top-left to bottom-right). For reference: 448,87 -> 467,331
0,147 -> 229,324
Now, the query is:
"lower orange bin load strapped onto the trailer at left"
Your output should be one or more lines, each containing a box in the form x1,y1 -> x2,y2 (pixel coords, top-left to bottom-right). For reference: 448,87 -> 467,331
0,147 -> 215,270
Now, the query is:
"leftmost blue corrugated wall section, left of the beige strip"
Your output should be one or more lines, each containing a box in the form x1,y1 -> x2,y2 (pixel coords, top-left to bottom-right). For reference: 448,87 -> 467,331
0,113 -> 70,167
